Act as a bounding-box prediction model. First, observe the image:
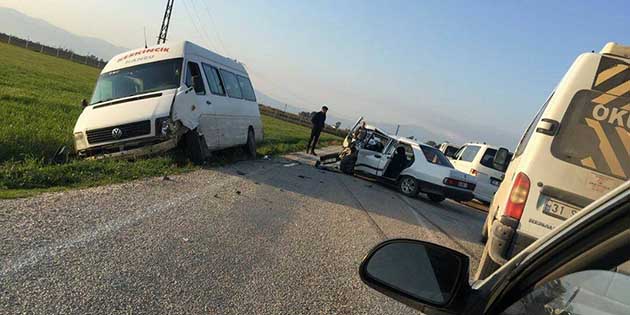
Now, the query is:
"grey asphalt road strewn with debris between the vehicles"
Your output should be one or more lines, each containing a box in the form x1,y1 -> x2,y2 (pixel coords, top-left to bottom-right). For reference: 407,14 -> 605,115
0,149 -> 485,314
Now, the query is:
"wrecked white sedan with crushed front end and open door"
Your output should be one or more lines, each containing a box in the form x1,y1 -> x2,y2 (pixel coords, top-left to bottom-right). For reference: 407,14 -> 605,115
321,119 -> 475,202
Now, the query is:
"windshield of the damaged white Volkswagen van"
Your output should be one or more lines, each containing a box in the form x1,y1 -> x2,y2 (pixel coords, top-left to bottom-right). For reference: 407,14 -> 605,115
90,58 -> 182,105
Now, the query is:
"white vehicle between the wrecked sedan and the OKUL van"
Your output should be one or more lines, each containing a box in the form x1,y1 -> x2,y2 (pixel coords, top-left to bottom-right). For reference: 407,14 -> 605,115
450,143 -> 511,205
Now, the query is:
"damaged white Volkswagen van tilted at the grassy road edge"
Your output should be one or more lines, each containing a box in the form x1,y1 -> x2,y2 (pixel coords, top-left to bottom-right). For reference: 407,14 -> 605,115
74,42 -> 263,162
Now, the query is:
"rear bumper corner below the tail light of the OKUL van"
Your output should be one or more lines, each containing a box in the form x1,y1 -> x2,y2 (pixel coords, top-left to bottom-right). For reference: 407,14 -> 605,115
488,216 -> 536,265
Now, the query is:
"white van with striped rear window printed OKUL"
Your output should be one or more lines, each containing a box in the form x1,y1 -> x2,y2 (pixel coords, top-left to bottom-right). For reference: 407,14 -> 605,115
476,43 -> 630,279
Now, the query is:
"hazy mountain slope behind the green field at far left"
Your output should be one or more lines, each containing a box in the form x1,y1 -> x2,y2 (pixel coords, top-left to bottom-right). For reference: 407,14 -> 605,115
0,7 -> 129,60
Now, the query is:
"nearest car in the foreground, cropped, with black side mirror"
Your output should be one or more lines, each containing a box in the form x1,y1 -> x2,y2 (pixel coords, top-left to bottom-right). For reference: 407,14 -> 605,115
359,182 -> 630,315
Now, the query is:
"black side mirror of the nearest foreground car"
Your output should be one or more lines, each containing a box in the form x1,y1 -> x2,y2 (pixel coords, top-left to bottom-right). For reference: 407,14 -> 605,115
359,239 -> 470,313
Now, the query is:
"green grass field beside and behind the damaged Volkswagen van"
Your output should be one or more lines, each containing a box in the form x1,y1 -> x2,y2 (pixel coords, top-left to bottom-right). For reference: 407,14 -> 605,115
0,43 -> 340,198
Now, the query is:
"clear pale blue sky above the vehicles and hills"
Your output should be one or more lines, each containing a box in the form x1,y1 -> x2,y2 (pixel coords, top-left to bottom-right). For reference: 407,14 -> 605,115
0,0 -> 630,148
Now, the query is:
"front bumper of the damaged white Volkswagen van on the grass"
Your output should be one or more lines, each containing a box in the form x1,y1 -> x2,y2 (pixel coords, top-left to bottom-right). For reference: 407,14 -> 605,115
77,136 -> 179,160
